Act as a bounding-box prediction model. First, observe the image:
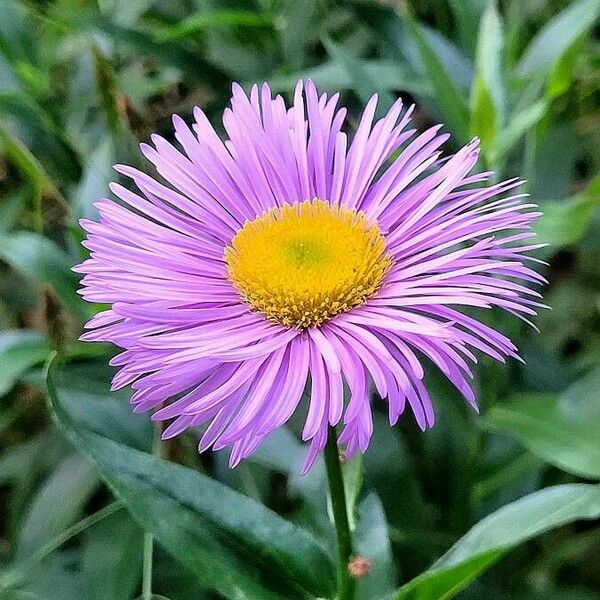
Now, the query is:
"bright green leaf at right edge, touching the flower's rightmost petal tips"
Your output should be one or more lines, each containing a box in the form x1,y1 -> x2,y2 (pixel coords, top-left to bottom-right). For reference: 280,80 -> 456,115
534,176 -> 600,251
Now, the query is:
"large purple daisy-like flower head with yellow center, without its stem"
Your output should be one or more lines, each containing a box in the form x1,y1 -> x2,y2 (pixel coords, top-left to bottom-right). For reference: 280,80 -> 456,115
77,82 -> 543,468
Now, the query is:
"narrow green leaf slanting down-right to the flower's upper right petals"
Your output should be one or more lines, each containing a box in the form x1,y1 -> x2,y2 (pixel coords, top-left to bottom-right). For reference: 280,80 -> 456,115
406,18 -> 469,142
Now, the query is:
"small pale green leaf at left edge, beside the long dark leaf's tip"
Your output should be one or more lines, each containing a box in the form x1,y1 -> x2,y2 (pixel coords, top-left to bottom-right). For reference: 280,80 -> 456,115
0,330 -> 50,396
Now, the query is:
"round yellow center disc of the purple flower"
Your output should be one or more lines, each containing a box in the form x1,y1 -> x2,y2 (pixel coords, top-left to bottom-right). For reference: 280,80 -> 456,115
225,198 -> 392,329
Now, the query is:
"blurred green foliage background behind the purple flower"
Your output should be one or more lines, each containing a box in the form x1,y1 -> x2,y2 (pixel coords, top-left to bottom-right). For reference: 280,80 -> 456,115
0,0 -> 600,600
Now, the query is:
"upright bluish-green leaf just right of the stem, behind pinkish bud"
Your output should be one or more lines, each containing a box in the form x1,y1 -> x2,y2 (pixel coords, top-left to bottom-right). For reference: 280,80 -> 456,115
354,493 -> 396,600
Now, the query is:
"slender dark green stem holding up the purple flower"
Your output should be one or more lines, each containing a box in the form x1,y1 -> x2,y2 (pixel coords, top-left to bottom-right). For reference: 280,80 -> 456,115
325,427 -> 355,600
